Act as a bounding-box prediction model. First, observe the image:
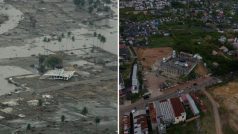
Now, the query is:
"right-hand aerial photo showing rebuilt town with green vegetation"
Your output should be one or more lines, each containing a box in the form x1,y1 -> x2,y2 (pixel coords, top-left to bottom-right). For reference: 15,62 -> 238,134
119,0 -> 238,134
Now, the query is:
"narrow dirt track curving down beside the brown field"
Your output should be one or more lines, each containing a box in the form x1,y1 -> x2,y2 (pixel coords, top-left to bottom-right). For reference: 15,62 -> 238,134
202,90 -> 222,134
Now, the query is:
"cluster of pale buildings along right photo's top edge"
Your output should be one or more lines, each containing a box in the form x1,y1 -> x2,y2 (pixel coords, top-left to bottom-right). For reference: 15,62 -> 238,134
120,0 -> 170,11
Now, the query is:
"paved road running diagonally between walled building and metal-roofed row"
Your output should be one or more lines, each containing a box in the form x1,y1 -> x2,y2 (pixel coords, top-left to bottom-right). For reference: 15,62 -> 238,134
120,77 -> 217,116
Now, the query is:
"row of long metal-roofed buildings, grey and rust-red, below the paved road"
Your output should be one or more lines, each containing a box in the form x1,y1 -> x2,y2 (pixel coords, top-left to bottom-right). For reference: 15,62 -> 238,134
122,94 -> 204,134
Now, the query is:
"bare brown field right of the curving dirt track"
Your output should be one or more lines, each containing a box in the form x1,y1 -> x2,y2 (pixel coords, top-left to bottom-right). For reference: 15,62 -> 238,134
210,80 -> 238,134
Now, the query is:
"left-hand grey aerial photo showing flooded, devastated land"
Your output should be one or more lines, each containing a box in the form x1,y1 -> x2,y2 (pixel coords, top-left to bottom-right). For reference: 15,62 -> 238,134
0,0 -> 119,134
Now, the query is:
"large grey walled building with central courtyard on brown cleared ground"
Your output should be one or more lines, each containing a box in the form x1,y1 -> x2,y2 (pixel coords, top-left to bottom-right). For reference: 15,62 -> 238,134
158,51 -> 202,78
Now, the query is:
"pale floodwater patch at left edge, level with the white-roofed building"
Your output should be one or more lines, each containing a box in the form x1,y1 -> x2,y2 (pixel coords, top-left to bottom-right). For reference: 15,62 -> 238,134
0,66 -> 31,95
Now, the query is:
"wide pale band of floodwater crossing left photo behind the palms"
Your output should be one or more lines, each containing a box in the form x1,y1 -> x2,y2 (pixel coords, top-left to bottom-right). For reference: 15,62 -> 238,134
0,24 -> 117,59
